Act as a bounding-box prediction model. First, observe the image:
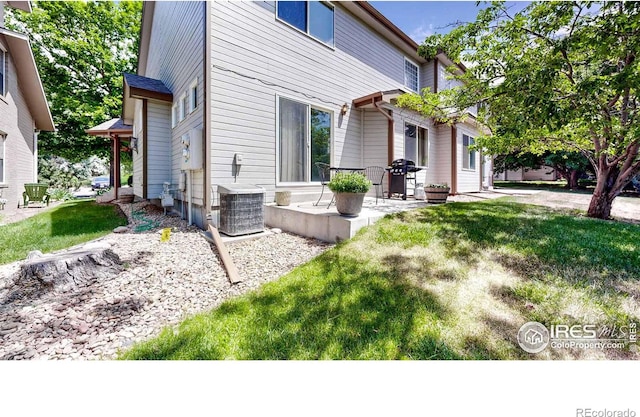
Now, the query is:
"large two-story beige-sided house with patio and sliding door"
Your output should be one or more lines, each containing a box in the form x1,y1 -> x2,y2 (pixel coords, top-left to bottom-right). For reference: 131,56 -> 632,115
123,1 -> 492,226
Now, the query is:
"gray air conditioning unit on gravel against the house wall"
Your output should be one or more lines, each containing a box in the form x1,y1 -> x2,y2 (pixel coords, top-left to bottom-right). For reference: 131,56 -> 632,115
218,184 -> 265,236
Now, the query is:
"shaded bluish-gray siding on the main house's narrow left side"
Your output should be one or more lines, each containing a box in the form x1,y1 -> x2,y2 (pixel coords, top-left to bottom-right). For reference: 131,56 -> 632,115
139,2 -> 206,211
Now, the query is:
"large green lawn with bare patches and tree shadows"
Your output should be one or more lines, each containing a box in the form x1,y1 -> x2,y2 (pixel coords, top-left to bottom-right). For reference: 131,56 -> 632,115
121,200 -> 640,359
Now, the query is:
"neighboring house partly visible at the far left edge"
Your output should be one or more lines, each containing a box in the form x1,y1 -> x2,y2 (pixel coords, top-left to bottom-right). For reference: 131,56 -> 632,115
0,0 -> 55,210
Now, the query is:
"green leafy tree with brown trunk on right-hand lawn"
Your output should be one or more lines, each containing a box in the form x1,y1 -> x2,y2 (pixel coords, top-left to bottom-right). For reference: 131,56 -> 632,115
399,1 -> 640,219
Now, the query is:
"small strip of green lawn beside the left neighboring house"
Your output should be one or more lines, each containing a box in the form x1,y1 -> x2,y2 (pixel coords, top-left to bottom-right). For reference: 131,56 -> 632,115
0,200 -> 127,264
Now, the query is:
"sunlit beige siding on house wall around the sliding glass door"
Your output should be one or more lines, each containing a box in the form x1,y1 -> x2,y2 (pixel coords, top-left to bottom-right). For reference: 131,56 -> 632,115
211,2 -> 420,201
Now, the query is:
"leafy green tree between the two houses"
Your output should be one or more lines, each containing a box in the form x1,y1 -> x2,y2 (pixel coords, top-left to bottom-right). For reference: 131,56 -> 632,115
7,1 -> 142,161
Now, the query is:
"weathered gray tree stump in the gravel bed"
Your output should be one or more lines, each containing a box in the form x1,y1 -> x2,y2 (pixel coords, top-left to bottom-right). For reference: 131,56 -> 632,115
18,247 -> 124,291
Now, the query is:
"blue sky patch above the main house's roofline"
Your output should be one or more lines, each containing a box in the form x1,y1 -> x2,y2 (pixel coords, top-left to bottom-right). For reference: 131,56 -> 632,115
370,1 -> 529,43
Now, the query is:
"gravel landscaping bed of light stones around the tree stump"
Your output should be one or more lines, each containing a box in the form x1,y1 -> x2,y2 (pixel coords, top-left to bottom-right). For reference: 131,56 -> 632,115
0,202 -> 331,360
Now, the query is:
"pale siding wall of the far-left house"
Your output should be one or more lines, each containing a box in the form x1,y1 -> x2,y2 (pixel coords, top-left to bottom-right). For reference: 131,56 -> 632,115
0,36 -> 37,211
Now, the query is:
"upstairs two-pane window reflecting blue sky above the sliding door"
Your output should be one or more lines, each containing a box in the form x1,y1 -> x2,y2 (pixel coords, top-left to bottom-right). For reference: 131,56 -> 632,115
276,1 -> 334,47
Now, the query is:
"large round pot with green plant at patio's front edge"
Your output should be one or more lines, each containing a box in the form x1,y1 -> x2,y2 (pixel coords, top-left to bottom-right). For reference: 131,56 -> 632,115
327,172 -> 371,216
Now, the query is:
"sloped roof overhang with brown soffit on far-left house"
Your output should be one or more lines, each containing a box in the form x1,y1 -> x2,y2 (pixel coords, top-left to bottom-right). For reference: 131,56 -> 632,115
0,28 -> 55,132
